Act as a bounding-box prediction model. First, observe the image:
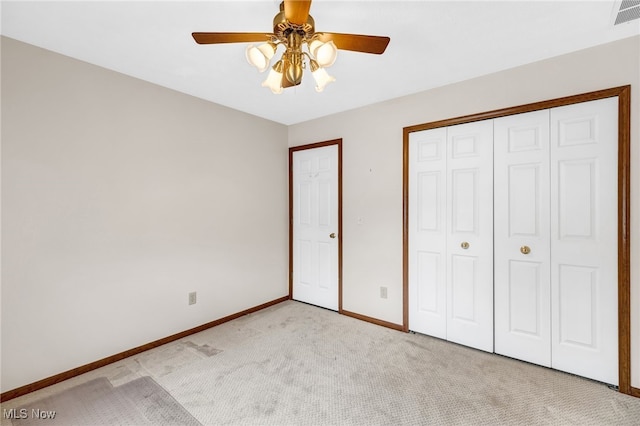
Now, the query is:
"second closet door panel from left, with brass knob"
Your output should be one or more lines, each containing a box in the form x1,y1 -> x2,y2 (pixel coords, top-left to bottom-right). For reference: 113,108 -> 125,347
446,120 -> 493,352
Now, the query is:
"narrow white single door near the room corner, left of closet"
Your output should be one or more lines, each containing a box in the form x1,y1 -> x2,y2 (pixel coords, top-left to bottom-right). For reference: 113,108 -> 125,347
292,144 -> 339,310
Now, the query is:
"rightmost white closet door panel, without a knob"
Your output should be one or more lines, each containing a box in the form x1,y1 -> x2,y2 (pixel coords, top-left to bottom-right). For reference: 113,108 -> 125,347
551,98 -> 618,385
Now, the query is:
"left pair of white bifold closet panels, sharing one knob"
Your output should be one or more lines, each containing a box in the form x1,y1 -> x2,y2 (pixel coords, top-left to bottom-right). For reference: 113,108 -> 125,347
409,120 -> 493,352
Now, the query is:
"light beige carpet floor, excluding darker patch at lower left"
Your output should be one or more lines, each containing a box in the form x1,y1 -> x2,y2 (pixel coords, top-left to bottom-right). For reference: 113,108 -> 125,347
3,301 -> 640,426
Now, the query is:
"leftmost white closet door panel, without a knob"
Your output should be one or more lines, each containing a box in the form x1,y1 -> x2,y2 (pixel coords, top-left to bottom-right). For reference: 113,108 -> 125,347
409,127 -> 447,339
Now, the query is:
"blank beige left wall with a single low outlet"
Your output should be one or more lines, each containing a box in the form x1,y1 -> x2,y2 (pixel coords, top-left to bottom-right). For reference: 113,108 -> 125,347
2,38 -> 288,391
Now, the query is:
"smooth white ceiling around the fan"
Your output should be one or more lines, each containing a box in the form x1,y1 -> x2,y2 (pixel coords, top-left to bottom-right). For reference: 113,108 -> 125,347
1,0 -> 640,125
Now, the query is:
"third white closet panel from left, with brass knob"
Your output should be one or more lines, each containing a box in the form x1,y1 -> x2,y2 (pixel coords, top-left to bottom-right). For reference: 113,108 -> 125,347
494,110 -> 551,367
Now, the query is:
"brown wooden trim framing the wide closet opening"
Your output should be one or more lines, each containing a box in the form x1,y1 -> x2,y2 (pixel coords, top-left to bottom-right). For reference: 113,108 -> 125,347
402,85 -> 640,397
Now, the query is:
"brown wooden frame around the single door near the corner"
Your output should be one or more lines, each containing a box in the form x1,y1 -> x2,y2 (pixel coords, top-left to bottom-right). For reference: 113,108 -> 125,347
289,139 -> 343,313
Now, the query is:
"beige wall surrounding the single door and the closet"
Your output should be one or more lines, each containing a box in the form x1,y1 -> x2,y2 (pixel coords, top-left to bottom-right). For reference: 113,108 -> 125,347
289,37 -> 640,387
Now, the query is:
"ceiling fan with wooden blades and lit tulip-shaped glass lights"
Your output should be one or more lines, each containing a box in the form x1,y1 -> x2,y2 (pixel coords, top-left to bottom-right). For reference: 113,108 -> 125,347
191,0 -> 390,94
